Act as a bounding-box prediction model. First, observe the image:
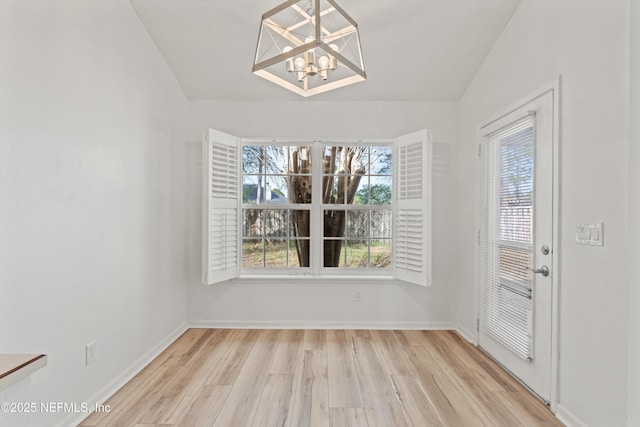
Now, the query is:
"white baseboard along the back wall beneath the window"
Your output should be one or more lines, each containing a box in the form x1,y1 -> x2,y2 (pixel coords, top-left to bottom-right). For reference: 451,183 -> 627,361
189,320 -> 456,330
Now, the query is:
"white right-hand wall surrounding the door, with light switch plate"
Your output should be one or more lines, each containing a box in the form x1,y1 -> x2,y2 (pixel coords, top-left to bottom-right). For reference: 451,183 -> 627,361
456,0 -> 637,427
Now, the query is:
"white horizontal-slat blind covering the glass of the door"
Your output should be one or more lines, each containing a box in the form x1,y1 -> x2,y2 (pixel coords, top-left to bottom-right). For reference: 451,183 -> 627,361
480,114 -> 535,359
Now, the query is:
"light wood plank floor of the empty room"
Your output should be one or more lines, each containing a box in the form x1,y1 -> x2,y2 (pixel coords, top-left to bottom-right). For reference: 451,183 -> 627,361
80,329 -> 562,427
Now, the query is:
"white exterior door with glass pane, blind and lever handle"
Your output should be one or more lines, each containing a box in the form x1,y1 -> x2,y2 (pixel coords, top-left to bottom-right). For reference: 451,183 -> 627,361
478,90 -> 554,402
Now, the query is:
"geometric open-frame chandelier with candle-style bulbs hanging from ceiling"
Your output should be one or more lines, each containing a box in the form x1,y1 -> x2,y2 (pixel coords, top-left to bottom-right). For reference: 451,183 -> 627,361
253,0 -> 367,97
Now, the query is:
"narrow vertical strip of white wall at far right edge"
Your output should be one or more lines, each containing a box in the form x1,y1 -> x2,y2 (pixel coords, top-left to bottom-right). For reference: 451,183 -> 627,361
627,1 -> 640,427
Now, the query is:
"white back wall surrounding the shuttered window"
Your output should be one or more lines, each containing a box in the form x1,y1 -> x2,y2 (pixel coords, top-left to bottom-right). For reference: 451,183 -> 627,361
189,100 -> 458,327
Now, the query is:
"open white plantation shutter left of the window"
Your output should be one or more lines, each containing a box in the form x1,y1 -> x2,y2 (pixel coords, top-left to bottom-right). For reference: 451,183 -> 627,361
202,129 -> 240,285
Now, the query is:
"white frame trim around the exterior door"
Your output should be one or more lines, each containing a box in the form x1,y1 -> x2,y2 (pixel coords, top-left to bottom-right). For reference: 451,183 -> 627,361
474,75 -> 562,414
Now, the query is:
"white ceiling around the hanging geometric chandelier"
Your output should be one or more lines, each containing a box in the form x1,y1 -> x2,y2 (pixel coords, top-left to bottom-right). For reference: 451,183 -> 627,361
131,0 -> 520,101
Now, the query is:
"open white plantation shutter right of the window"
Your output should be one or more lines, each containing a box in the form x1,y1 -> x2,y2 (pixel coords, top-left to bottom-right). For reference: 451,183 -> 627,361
393,130 -> 432,286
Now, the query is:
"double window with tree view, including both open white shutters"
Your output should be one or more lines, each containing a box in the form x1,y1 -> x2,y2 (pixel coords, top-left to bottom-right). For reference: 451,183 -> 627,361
203,129 -> 431,285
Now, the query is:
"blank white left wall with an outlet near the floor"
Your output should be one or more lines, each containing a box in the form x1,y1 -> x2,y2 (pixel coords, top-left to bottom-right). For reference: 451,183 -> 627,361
0,0 -> 188,426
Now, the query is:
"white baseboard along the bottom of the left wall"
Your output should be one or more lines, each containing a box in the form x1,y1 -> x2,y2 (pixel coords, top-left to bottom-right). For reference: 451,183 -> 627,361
58,322 -> 189,427
